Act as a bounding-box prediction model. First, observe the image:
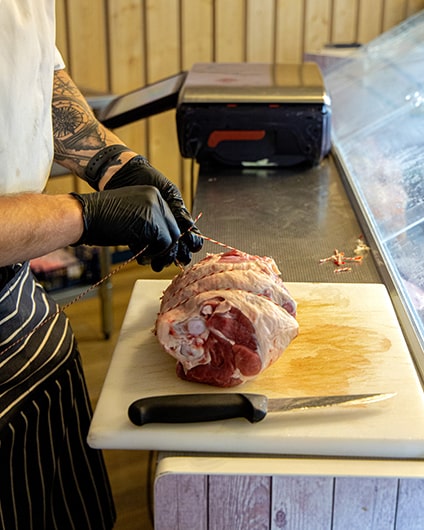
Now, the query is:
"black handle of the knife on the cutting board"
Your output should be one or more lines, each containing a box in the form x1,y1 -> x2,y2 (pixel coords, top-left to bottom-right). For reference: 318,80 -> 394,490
128,393 -> 268,425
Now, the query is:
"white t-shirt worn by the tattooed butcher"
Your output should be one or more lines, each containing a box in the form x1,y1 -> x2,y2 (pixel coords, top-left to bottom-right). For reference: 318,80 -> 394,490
0,0 -> 64,194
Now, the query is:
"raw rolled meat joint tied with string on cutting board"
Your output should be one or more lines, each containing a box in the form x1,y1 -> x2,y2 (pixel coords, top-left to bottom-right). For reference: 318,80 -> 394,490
155,250 -> 298,387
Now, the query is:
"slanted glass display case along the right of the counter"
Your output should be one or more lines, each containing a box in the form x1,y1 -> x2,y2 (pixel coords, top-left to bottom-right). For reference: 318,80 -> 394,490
325,11 -> 424,377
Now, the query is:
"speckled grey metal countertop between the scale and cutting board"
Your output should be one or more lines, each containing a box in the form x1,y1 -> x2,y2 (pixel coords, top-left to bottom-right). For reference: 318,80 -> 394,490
193,156 -> 381,283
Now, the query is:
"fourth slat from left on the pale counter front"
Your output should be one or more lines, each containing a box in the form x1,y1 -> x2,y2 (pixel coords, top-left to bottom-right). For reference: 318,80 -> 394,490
334,477 -> 398,530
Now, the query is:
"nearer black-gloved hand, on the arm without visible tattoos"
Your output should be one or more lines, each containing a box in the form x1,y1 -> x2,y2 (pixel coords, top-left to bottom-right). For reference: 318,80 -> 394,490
71,186 -> 180,272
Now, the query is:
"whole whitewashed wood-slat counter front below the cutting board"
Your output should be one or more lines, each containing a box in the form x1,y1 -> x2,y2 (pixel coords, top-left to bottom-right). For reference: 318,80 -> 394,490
154,472 -> 424,530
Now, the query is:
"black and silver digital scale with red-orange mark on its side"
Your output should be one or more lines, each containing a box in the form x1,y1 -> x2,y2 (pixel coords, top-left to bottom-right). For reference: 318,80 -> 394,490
98,62 -> 331,166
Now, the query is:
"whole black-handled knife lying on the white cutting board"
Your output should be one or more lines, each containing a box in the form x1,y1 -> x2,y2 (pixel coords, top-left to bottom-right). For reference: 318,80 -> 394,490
128,392 -> 395,425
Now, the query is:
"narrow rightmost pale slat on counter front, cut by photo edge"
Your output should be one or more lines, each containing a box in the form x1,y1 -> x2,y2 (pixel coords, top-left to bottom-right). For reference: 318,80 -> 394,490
396,479 -> 424,530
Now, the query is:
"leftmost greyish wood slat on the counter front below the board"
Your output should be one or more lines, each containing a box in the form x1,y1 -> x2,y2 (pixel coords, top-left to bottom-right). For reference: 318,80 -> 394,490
154,474 -> 209,530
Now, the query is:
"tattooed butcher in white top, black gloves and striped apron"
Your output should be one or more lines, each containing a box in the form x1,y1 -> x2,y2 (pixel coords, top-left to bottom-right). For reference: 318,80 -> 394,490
0,0 -> 202,530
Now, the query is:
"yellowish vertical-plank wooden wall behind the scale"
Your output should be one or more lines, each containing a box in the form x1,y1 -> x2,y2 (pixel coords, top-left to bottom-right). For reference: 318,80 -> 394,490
57,0 -> 424,204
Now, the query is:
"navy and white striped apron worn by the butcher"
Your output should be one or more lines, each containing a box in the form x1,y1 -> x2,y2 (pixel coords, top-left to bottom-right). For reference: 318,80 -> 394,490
0,263 -> 115,530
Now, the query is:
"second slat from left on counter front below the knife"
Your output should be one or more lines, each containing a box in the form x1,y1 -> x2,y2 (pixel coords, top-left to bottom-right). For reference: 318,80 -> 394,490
209,475 -> 271,530
